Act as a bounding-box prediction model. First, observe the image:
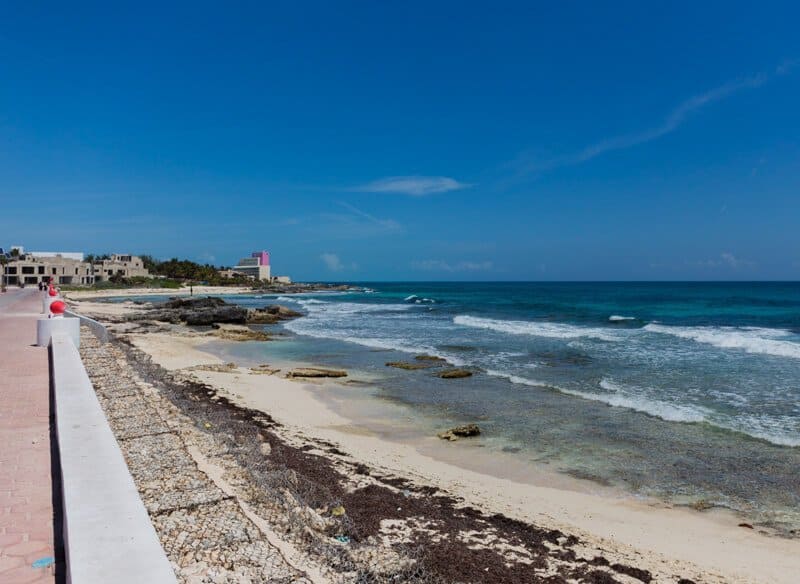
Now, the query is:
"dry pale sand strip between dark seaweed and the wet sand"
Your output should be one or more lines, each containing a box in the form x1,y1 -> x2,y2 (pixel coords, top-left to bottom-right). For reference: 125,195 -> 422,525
164,336 -> 800,584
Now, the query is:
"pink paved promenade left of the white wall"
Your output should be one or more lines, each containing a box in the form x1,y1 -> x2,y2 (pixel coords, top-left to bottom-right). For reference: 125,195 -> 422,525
0,288 -> 55,584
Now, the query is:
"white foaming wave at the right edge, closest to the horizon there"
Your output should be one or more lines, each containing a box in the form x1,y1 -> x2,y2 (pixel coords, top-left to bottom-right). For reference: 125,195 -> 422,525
643,323 -> 800,359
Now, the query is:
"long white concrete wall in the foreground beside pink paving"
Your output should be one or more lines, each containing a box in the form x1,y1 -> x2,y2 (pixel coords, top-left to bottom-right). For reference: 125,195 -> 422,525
50,333 -> 176,584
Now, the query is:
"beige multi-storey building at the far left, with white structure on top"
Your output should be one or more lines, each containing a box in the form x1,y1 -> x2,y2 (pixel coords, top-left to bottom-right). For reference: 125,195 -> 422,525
3,252 -> 94,285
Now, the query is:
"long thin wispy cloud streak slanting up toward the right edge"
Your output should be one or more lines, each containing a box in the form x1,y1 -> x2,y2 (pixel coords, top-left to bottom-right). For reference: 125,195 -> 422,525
512,61 -> 798,176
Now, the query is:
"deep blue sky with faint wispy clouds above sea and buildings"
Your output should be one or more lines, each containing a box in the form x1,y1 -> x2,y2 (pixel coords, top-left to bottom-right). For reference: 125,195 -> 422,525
0,1 -> 800,281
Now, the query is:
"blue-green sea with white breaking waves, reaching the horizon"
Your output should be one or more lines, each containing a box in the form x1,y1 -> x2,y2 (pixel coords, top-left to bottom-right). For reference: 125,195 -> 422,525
122,283 -> 800,533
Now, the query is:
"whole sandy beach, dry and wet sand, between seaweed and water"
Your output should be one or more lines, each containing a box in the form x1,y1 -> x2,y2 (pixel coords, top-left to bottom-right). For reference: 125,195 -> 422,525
67,292 -> 800,584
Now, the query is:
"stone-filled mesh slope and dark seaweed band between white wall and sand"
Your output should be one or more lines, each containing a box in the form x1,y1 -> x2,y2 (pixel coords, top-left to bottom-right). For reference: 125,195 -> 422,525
70,314 -> 708,584
